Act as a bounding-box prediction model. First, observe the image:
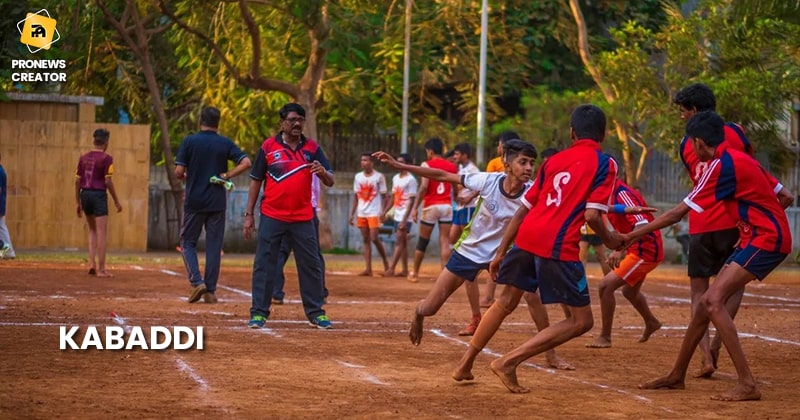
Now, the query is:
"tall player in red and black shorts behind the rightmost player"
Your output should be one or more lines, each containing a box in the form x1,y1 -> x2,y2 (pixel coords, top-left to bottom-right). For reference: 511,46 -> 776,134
673,83 -> 753,378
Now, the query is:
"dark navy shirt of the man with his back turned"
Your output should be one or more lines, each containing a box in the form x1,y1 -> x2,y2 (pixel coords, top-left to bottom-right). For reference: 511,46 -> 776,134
175,131 -> 246,212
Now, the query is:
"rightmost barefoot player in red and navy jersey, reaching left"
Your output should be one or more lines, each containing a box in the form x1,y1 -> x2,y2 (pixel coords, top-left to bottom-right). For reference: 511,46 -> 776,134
623,111 -> 792,401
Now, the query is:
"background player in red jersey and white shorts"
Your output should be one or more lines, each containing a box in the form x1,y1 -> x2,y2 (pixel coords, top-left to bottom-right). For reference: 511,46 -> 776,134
408,137 -> 458,283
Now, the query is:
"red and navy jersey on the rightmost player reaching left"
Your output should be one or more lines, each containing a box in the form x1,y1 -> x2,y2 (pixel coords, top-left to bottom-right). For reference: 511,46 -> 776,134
683,148 -> 792,254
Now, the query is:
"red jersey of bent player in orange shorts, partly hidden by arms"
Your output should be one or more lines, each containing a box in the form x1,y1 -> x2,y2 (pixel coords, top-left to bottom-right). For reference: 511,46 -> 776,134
608,179 -> 664,262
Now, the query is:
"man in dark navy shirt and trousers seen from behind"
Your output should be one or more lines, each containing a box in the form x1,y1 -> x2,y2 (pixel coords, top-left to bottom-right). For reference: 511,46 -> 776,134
175,107 -> 252,303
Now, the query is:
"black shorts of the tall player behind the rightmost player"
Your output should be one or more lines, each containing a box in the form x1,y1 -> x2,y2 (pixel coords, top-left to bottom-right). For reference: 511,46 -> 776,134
689,228 -> 739,277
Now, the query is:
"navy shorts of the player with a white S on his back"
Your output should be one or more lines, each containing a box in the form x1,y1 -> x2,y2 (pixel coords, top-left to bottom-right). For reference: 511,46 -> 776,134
497,247 -> 591,307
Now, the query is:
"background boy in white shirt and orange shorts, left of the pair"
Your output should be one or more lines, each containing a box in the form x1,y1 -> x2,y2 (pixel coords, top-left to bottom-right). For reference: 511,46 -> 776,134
350,153 -> 389,276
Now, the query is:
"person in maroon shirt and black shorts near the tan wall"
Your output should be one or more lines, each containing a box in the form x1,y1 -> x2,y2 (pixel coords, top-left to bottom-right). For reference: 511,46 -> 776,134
75,128 -> 122,277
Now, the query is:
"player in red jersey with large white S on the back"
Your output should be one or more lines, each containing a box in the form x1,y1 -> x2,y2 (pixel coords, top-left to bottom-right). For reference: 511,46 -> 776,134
453,105 -> 622,393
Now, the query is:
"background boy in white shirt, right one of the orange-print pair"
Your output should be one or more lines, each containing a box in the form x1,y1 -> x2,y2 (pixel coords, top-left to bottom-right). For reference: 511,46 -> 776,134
383,153 -> 417,277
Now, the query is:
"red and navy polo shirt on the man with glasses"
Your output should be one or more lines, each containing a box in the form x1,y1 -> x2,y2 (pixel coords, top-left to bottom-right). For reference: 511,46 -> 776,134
250,133 -> 331,222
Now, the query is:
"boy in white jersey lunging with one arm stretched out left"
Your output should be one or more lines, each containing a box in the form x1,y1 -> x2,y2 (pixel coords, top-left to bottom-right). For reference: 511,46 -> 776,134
373,140 -> 572,369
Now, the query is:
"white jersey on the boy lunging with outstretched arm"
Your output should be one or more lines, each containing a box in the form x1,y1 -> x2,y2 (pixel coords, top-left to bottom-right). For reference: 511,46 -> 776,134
454,172 -> 533,264
